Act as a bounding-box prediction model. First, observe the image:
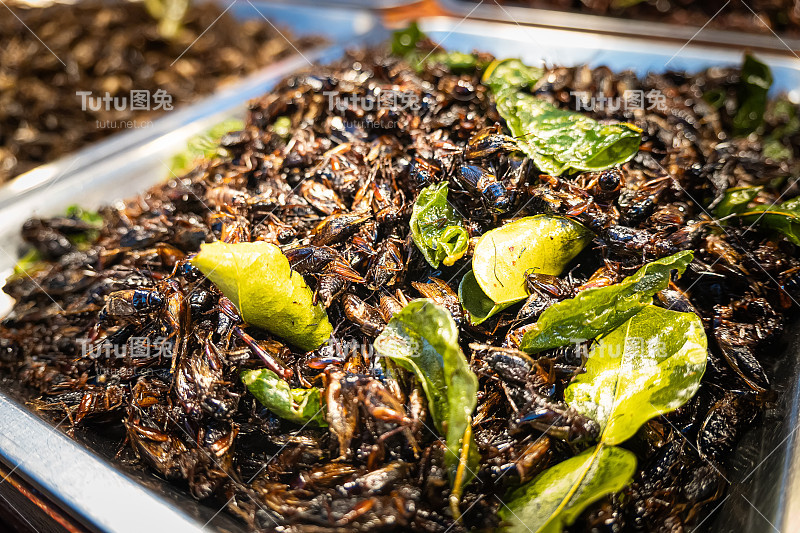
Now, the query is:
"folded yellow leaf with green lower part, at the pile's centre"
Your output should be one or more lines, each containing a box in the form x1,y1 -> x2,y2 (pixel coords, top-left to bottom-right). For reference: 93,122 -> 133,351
466,215 -> 592,324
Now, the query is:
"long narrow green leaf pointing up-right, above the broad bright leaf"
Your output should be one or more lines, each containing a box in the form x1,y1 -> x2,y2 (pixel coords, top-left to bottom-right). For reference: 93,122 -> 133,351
521,251 -> 694,353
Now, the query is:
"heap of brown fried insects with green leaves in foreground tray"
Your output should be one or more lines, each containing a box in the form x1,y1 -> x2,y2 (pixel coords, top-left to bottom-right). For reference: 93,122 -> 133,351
0,26 -> 800,532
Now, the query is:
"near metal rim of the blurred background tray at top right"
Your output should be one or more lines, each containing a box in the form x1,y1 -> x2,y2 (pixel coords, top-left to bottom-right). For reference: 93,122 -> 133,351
437,0 -> 800,55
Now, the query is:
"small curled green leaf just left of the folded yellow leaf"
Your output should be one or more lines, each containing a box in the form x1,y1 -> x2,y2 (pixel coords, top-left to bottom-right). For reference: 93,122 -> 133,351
410,181 -> 469,268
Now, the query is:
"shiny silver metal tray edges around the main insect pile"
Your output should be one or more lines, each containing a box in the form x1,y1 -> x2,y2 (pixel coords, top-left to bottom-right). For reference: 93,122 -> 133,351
0,12 -> 800,532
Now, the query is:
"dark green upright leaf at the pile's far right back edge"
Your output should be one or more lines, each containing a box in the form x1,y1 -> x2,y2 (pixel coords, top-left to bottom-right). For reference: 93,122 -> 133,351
733,54 -> 772,137
